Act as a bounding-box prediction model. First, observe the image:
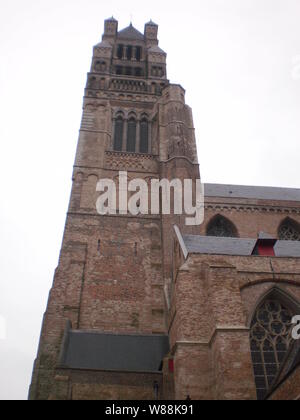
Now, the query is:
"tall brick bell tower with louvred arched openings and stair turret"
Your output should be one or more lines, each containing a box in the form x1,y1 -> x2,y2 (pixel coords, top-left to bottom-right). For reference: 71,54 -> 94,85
29,18 -> 199,400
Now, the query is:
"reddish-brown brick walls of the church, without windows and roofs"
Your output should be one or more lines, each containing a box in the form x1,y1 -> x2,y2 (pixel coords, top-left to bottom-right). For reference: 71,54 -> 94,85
29,20 -> 300,400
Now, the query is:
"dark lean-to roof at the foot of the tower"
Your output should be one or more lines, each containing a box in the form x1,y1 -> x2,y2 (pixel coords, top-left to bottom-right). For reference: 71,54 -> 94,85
60,330 -> 169,372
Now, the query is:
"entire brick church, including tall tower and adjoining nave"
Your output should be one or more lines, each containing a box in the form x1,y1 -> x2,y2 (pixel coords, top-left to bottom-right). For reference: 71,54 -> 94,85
29,18 -> 300,400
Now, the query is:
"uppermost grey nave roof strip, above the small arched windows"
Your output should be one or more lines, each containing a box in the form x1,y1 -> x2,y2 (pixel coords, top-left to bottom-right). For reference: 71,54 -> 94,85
204,184 -> 300,201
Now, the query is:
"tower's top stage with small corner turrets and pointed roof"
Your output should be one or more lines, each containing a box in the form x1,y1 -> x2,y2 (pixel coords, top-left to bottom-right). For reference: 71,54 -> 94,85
87,17 -> 168,96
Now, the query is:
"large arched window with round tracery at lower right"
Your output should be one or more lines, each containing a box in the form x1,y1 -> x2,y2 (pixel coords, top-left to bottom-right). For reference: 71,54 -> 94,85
250,294 -> 294,400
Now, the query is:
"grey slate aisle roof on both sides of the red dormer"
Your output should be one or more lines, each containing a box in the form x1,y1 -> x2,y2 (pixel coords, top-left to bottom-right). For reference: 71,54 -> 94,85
182,235 -> 300,258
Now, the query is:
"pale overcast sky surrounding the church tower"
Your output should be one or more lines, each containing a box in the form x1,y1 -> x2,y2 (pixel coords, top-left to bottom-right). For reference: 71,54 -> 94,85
0,0 -> 300,399
